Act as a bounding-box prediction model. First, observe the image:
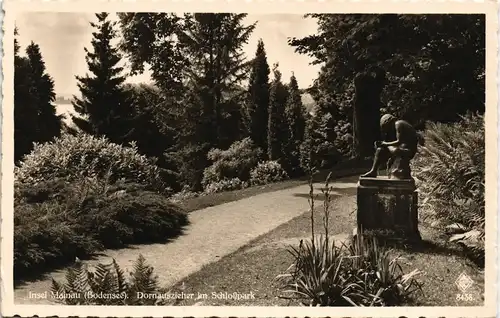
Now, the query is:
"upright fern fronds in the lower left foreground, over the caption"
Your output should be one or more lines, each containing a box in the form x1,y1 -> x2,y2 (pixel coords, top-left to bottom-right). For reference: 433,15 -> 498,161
51,254 -> 168,306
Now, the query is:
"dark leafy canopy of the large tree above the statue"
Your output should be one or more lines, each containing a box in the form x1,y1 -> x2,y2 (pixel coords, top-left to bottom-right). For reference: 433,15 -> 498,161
289,14 -> 485,155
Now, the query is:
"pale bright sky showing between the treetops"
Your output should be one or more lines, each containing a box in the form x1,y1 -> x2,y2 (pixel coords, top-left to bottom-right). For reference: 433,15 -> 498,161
16,12 -> 319,96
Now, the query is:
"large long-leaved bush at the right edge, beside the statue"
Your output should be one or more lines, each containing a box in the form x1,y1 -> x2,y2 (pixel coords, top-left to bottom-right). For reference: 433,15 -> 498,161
413,114 -> 485,264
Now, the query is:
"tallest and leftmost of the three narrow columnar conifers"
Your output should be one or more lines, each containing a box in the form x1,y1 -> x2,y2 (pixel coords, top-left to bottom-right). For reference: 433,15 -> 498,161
245,39 -> 270,154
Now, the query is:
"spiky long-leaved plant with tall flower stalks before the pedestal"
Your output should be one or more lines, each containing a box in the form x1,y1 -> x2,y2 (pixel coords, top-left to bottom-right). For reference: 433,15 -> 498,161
278,174 -> 420,306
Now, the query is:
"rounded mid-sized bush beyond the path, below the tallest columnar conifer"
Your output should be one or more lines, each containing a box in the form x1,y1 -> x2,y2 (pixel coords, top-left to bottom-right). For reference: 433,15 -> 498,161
202,138 -> 262,187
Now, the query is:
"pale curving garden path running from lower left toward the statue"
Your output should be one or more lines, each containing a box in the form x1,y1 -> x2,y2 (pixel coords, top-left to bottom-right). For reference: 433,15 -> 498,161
14,176 -> 358,304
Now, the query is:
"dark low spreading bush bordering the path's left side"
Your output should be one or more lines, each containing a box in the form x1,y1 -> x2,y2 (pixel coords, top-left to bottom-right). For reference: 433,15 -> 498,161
14,178 -> 187,275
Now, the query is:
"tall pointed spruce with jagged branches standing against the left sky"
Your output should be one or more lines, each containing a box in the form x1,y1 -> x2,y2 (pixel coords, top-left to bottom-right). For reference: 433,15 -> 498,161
72,12 -> 133,144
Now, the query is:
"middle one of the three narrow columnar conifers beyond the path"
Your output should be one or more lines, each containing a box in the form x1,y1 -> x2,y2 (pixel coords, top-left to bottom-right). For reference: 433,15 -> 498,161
267,63 -> 288,163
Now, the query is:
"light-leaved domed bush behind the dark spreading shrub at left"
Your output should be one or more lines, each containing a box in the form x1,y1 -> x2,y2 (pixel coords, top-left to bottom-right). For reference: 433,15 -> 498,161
16,134 -> 169,193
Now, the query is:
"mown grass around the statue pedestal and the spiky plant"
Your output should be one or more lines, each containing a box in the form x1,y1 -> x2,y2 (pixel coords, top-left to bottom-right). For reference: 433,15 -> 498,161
168,195 -> 484,306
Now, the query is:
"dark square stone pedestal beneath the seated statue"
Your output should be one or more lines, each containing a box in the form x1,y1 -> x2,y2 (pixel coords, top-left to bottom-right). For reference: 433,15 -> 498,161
357,177 -> 421,241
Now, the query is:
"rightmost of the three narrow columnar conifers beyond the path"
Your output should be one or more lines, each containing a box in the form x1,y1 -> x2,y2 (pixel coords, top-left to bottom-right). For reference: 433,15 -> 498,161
283,73 -> 306,176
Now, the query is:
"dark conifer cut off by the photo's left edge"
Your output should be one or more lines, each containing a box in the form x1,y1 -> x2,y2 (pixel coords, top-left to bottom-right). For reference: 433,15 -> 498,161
14,29 -> 62,163
